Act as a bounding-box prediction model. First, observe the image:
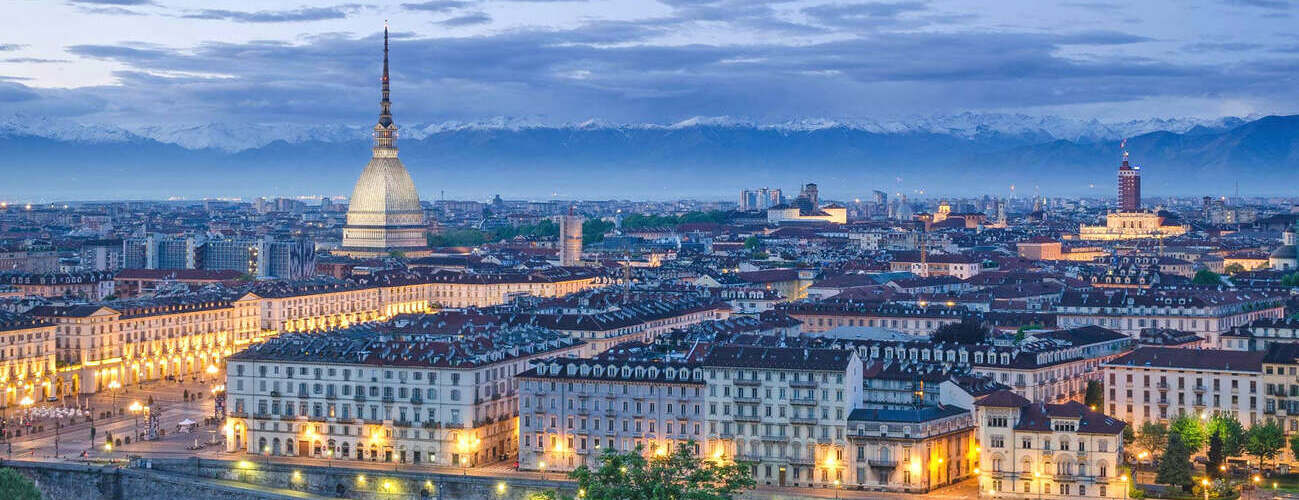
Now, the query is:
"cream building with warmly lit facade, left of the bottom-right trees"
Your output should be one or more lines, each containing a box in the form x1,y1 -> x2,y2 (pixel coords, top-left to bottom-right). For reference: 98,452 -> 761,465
974,391 -> 1129,500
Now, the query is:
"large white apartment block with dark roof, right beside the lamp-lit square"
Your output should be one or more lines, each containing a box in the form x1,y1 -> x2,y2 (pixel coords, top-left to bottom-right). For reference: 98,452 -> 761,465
225,326 -> 582,466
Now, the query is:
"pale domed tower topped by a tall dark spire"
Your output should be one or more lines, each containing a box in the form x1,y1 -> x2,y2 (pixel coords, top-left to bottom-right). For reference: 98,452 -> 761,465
335,26 -> 430,257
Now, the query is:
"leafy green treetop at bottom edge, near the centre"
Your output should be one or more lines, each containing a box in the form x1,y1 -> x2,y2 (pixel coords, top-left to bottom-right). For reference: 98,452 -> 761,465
546,442 -> 757,500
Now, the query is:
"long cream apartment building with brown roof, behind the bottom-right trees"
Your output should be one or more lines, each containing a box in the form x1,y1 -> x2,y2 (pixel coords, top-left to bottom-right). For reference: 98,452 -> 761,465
1102,347 -> 1265,427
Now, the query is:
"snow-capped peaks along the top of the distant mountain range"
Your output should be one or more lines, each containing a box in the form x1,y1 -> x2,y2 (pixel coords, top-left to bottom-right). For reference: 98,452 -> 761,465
0,113 -> 1257,152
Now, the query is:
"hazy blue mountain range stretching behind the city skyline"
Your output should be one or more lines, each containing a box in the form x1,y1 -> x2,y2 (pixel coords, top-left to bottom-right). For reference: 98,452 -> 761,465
0,113 -> 1299,201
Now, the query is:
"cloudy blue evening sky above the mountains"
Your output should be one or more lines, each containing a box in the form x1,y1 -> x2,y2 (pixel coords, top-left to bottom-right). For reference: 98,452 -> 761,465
0,0 -> 1299,126
